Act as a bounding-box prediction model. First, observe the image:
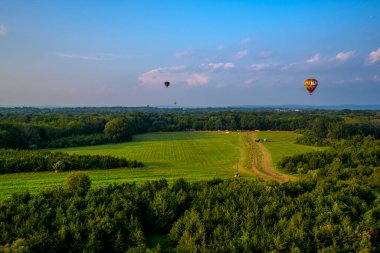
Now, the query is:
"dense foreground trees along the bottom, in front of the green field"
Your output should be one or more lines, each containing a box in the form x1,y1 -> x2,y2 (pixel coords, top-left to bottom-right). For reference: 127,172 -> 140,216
0,167 -> 380,252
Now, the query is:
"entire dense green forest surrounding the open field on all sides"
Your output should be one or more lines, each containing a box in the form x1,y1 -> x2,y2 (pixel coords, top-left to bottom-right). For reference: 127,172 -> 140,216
0,108 -> 380,252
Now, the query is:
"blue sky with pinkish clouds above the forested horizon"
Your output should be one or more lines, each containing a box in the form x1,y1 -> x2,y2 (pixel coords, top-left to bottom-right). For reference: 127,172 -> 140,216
0,0 -> 380,106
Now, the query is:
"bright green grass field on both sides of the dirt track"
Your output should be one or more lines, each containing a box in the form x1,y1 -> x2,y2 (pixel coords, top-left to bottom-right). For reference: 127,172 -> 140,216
0,132 -> 324,199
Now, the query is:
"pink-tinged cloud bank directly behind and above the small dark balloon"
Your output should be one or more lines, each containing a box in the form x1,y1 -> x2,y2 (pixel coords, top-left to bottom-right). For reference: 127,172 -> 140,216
138,65 -> 209,86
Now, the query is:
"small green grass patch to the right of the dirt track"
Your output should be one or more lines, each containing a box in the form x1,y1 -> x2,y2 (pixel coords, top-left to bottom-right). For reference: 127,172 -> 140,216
257,131 -> 326,168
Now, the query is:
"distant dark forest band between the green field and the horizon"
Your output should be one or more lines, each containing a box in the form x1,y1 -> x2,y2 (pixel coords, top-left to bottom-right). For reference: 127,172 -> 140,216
0,107 -> 380,149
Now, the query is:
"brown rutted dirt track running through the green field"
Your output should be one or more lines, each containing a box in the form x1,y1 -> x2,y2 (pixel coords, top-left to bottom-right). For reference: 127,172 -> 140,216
249,133 -> 297,183
